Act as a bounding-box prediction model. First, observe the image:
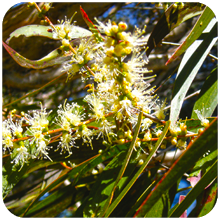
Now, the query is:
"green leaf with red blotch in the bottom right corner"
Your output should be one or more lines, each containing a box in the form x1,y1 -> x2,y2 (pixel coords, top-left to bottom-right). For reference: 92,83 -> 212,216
198,180 -> 218,217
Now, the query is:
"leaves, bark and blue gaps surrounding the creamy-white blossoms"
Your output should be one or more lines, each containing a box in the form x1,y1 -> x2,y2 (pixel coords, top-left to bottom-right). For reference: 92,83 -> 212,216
3,3 -> 217,217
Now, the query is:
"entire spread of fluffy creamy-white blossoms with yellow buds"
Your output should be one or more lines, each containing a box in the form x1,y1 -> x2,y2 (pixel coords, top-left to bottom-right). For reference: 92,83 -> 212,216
2,19 -> 206,168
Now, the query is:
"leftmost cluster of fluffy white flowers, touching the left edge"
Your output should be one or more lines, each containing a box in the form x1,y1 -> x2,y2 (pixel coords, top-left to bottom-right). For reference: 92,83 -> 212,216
2,105 -> 52,168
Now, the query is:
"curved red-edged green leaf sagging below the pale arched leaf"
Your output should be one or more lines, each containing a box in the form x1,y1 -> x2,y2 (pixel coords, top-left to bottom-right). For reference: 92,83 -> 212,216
2,42 -> 71,69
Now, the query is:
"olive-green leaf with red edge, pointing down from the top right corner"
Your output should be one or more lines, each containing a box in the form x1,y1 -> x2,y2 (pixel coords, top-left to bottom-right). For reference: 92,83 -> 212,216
165,6 -> 215,65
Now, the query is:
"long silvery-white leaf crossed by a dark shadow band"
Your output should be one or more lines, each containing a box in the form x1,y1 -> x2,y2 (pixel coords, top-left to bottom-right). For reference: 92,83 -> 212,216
170,18 -> 217,125
